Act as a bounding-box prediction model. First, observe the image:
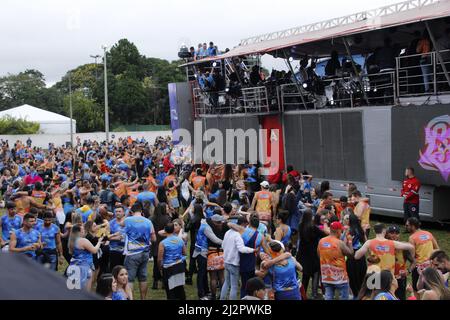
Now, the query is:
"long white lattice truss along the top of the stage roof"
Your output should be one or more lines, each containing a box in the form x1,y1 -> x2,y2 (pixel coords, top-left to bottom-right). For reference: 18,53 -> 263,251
239,0 -> 440,46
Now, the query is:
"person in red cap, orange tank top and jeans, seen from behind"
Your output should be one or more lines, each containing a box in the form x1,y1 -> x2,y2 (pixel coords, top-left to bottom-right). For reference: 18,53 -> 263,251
317,222 -> 353,300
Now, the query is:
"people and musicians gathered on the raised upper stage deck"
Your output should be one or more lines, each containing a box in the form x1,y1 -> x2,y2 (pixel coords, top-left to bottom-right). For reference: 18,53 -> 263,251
190,28 -> 450,113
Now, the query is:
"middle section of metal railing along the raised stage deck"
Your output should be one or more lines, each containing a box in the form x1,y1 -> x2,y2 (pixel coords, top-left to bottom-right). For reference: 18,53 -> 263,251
280,69 -> 396,111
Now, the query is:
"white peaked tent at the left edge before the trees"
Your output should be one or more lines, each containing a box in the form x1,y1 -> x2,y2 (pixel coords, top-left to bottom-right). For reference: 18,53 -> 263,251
0,104 -> 77,134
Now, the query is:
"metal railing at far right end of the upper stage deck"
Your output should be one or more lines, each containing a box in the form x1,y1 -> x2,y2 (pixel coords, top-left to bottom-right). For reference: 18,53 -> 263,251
396,50 -> 450,98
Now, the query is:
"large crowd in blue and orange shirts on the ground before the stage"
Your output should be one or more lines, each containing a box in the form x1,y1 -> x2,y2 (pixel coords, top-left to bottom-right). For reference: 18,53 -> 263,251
0,137 -> 450,300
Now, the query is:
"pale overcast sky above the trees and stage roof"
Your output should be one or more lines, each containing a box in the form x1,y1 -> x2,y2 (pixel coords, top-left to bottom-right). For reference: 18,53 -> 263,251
0,0 -> 400,83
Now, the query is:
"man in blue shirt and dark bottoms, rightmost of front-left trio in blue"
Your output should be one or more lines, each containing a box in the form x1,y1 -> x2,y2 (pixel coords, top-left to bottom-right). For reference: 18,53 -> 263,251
37,211 -> 63,271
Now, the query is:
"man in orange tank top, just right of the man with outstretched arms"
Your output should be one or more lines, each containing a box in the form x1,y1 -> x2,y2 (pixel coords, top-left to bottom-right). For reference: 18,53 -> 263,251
406,217 -> 439,297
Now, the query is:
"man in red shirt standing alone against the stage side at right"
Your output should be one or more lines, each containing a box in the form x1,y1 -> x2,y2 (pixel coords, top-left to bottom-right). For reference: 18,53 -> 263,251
401,168 -> 420,221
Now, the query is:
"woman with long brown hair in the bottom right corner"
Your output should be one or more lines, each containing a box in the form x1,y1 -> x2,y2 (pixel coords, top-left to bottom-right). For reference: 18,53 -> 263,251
419,267 -> 450,300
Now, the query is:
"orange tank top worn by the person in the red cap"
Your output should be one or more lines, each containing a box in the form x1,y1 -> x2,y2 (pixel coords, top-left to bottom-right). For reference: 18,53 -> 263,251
318,236 -> 348,284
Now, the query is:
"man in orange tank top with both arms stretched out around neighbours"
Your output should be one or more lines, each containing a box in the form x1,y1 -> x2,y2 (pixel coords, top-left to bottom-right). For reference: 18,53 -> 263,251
355,223 -> 414,274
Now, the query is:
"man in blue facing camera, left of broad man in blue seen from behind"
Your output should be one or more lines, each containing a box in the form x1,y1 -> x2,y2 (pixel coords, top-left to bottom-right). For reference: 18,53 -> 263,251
109,207 -> 125,270
